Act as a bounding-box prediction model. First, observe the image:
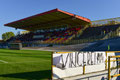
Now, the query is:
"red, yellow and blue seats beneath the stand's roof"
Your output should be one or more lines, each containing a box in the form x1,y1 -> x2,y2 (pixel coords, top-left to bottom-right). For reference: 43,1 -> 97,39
8,27 -> 81,44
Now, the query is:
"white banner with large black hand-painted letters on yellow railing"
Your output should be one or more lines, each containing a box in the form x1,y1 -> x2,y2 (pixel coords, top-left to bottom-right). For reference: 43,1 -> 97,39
53,52 -> 106,68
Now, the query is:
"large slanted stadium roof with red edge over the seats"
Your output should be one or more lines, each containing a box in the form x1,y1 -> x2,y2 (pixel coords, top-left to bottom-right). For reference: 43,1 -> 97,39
5,9 -> 91,31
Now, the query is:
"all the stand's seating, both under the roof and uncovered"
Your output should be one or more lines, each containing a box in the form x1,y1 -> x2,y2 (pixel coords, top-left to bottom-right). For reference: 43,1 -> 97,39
8,25 -> 119,44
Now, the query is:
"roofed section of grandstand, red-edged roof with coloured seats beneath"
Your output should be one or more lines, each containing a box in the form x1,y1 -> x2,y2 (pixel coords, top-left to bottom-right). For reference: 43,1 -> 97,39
5,9 -> 90,46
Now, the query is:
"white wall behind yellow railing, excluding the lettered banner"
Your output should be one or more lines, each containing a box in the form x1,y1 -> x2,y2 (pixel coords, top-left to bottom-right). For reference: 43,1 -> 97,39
53,52 -> 116,80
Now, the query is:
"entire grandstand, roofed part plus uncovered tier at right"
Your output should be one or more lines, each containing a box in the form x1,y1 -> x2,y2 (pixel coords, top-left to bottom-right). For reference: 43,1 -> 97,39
4,9 -> 120,50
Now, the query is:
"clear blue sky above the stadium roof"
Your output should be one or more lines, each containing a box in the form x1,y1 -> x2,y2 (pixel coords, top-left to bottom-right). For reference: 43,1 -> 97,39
0,0 -> 120,39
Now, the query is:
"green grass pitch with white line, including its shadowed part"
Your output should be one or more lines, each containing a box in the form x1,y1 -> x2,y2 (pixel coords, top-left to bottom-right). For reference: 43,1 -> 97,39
0,49 -> 52,80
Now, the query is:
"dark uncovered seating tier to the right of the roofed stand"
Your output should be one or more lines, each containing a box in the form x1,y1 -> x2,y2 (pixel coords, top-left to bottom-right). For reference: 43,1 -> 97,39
73,25 -> 119,40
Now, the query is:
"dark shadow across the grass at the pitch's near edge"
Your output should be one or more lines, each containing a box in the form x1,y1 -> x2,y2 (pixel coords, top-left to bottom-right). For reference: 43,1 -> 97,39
0,70 -> 51,80
